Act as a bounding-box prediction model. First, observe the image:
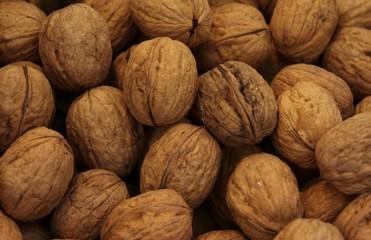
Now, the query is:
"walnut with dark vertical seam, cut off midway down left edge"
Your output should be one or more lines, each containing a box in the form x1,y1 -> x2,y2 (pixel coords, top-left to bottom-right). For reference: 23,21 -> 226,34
0,64 -> 55,152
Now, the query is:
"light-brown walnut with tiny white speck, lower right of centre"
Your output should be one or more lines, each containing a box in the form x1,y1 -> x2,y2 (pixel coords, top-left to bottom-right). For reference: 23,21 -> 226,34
226,153 -> 303,240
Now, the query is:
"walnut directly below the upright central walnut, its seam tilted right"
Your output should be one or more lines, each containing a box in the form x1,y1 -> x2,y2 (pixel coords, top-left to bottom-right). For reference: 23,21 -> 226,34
140,123 -> 221,209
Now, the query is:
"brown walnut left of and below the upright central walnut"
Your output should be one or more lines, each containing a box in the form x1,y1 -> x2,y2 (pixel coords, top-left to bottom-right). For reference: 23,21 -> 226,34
66,86 -> 144,177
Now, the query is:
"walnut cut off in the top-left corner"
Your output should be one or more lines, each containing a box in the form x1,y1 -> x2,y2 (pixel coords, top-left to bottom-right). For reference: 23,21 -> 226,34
0,1 -> 46,64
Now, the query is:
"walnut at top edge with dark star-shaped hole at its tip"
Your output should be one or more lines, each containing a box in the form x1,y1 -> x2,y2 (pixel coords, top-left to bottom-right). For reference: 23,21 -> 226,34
129,0 -> 211,48
